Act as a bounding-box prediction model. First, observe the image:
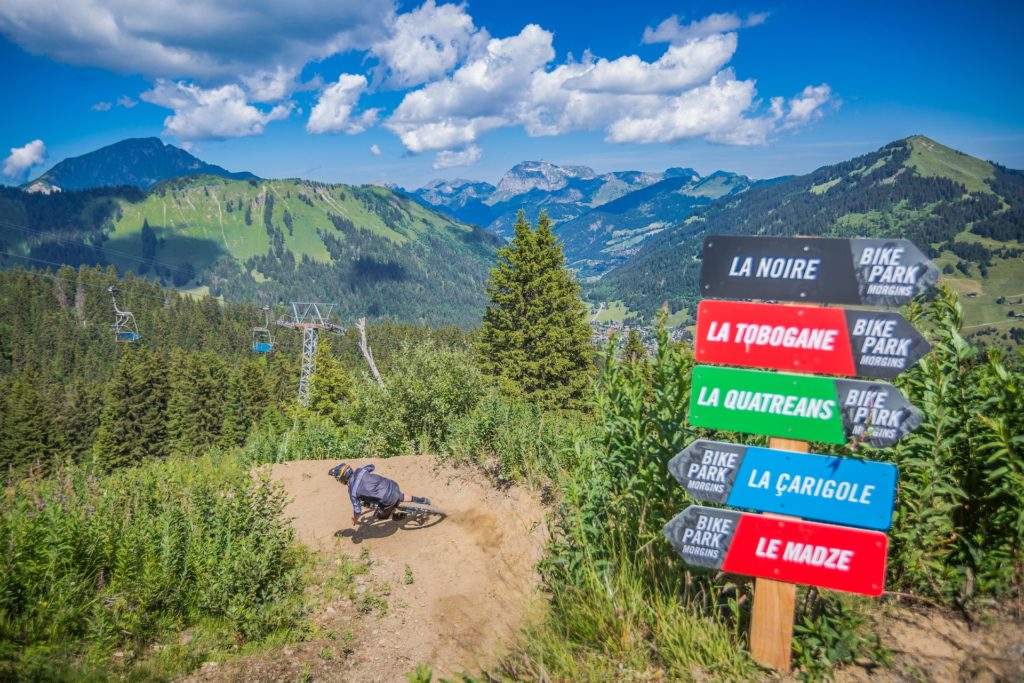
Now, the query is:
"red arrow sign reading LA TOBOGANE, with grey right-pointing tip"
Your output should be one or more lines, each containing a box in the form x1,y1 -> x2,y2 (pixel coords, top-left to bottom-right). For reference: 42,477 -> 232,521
695,300 -> 931,379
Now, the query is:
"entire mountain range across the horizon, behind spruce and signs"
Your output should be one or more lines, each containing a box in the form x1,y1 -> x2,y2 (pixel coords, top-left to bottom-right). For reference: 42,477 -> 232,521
0,136 -> 1024,335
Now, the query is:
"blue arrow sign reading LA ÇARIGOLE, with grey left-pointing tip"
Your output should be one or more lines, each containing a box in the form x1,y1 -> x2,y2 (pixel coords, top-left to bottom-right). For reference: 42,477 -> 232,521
669,440 -> 896,531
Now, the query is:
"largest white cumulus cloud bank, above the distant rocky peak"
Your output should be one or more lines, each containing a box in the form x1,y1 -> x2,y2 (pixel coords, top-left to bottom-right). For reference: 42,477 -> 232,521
385,14 -> 831,155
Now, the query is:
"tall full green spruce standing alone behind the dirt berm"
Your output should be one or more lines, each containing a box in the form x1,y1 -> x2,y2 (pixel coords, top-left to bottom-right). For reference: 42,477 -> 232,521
479,211 -> 593,408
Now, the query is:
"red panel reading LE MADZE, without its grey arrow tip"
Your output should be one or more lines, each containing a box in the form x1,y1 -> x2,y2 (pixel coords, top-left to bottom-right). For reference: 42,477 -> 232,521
722,514 -> 889,597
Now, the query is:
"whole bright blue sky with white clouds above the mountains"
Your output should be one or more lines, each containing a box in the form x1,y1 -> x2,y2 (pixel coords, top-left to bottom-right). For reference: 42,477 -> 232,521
0,0 -> 1024,187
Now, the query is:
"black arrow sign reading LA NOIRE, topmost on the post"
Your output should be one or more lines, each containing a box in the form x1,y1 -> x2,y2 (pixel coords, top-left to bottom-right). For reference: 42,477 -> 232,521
700,236 -> 939,306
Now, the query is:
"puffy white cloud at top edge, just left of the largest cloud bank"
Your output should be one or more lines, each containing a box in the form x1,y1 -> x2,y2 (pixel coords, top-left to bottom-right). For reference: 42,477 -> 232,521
371,0 -> 488,88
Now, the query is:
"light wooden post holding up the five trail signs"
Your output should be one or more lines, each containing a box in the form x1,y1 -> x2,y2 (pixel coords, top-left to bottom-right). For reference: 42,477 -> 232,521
751,437 -> 809,673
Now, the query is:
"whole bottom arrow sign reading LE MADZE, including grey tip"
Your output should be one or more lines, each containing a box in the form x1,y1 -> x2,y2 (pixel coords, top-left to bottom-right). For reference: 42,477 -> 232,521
664,505 -> 889,597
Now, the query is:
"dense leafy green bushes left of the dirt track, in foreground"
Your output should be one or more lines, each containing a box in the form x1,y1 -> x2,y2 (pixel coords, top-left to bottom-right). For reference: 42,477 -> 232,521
0,455 -> 302,680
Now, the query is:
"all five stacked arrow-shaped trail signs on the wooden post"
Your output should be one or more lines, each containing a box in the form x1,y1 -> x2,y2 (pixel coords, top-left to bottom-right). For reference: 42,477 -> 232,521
665,236 -> 938,596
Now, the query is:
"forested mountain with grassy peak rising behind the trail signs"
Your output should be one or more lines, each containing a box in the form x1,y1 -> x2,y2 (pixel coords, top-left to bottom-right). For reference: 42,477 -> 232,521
590,136 -> 1024,326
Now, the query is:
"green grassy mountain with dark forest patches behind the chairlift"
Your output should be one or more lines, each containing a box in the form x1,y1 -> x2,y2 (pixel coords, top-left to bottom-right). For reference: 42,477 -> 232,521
0,176 -> 501,326
